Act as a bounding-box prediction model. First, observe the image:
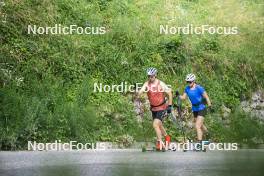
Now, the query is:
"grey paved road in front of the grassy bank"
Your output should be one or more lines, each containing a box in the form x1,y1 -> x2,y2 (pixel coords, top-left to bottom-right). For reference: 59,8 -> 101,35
0,149 -> 264,176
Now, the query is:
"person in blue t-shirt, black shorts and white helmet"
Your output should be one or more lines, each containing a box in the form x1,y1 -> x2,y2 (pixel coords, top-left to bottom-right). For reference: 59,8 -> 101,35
180,74 -> 211,141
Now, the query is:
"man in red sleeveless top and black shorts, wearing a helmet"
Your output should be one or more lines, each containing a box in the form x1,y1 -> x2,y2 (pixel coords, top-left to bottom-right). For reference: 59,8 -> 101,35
138,68 -> 172,150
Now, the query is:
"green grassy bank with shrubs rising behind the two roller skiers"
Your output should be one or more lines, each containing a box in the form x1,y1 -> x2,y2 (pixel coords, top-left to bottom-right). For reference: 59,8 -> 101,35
0,0 -> 264,150
